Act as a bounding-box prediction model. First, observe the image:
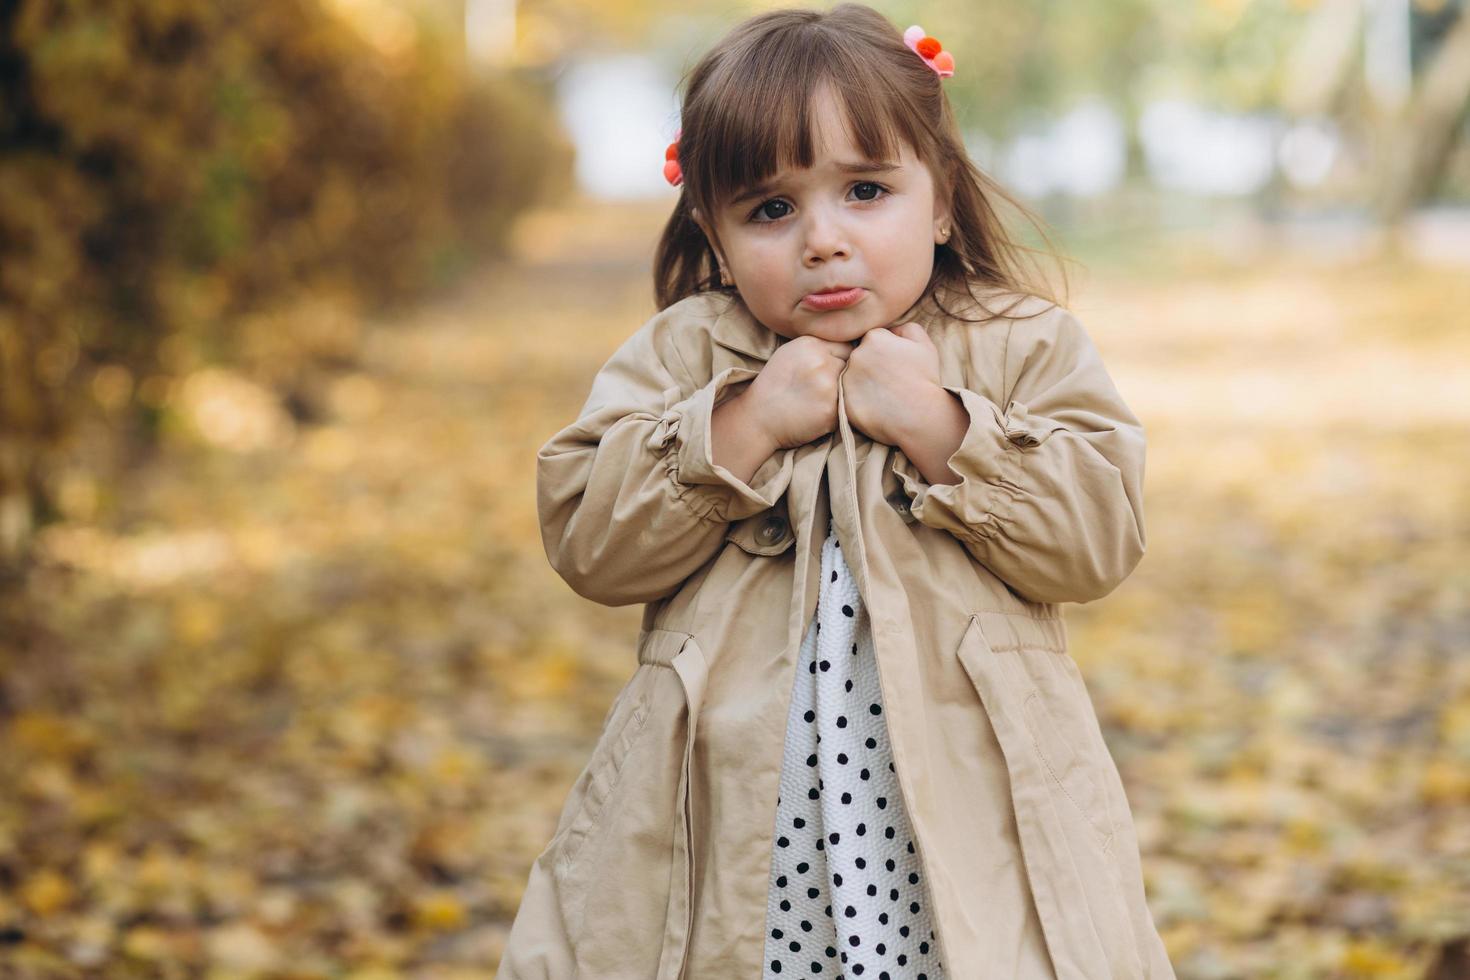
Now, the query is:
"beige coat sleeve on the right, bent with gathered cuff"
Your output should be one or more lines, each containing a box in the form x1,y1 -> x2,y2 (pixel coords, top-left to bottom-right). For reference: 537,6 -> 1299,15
892,307 -> 1147,602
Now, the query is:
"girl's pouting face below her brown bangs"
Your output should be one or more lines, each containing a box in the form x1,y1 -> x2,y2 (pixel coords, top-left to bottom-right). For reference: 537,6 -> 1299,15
700,88 -> 950,341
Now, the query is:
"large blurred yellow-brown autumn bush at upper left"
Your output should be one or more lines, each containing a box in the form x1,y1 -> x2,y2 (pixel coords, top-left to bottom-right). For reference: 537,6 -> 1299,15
0,0 -> 570,572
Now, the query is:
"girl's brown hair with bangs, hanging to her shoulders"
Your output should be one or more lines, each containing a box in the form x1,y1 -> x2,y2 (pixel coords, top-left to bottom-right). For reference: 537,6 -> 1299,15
654,3 -> 1066,326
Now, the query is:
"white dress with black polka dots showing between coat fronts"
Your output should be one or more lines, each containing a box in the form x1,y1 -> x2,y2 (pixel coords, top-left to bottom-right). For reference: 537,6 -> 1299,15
763,520 -> 944,980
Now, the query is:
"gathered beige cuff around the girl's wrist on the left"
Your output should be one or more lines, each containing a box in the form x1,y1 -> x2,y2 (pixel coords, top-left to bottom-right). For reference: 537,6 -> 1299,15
648,367 -> 792,523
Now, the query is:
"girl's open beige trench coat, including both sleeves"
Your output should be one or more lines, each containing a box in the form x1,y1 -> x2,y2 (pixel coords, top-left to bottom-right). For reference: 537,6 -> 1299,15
497,279 -> 1175,980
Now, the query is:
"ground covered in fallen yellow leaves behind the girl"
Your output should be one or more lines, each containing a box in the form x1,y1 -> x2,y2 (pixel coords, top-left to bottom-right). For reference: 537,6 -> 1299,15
0,206 -> 1470,980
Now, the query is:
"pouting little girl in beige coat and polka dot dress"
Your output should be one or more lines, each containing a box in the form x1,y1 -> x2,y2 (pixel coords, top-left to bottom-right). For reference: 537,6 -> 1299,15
497,3 -> 1173,980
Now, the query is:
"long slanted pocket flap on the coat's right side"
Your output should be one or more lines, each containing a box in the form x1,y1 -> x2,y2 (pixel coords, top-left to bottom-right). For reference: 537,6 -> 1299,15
958,614 -> 1145,980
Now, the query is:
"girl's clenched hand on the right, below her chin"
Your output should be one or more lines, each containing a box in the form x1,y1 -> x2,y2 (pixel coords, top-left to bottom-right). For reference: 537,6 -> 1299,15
842,322 -> 957,448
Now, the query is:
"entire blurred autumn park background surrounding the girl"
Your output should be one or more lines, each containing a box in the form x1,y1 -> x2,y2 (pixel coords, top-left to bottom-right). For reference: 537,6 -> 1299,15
0,0 -> 1470,980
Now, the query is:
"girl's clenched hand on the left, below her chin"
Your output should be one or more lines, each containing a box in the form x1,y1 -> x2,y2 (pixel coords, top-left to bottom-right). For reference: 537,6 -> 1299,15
739,336 -> 854,450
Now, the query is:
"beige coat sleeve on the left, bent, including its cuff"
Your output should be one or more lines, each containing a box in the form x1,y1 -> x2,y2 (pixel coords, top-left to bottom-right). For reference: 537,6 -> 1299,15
537,307 -> 792,605
